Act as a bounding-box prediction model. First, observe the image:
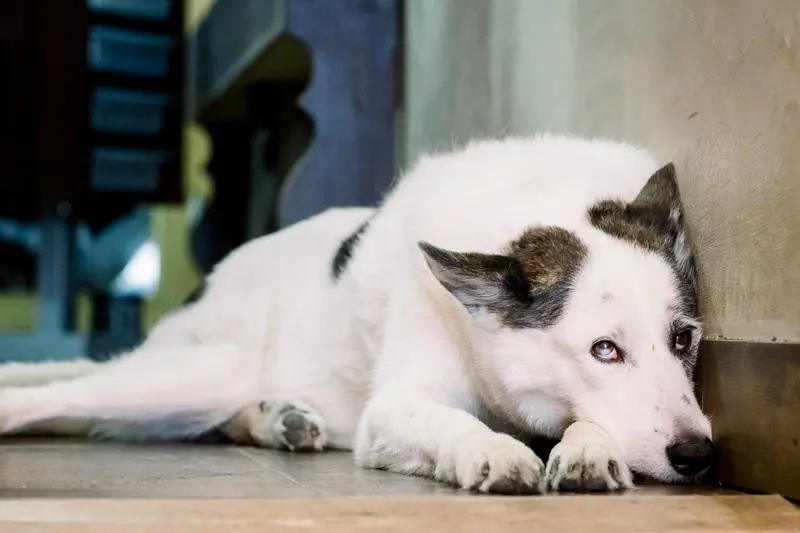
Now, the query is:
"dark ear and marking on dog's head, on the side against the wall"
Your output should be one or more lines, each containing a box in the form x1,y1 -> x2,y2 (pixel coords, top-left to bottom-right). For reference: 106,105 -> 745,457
589,163 -> 699,317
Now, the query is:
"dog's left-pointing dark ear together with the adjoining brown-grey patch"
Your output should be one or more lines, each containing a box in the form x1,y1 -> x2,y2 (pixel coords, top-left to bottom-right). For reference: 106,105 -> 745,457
419,227 -> 587,328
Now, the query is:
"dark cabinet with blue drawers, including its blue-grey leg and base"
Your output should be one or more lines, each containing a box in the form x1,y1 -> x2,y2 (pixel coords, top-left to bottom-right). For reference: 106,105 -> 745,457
0,0 -> 184,360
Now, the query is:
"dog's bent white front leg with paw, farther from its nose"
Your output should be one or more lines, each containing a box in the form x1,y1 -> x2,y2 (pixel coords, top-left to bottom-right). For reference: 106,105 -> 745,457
354,280 -> 544,494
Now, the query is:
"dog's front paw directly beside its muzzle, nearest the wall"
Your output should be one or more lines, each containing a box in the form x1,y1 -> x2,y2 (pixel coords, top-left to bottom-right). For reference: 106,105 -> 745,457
547,441 -> 633,492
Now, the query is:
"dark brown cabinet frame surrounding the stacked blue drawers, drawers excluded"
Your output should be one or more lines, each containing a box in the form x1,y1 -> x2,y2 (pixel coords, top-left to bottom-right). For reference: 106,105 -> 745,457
0,0 -> 183,228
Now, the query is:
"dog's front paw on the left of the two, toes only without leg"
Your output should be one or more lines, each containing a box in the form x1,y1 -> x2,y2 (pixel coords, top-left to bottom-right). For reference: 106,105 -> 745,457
453,433 -> 544,494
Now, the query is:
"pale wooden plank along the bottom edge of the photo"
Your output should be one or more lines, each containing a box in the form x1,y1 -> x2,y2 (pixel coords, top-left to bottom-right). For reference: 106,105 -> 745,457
0,495 -> 800,533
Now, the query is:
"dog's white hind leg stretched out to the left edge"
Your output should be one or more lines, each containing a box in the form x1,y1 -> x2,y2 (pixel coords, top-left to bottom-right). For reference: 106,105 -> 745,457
0,345 -> 258,440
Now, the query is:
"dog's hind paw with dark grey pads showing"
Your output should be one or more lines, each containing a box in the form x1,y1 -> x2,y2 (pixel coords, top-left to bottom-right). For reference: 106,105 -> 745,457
219,401 -> 327,452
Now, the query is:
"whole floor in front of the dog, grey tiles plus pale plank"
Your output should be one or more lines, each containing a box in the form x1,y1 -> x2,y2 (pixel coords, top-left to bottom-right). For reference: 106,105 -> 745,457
0,441 -> 800,533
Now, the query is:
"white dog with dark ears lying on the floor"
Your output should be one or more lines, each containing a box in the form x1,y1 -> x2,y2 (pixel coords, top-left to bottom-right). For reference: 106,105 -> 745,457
0,136 -> 714,493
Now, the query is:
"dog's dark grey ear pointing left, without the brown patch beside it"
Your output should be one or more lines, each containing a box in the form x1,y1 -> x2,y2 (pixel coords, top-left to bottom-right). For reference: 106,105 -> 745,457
419,242 -> 530,311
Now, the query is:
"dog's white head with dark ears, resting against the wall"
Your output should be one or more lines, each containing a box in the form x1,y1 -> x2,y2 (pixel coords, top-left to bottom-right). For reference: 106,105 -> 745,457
420,164 -> 713,481
